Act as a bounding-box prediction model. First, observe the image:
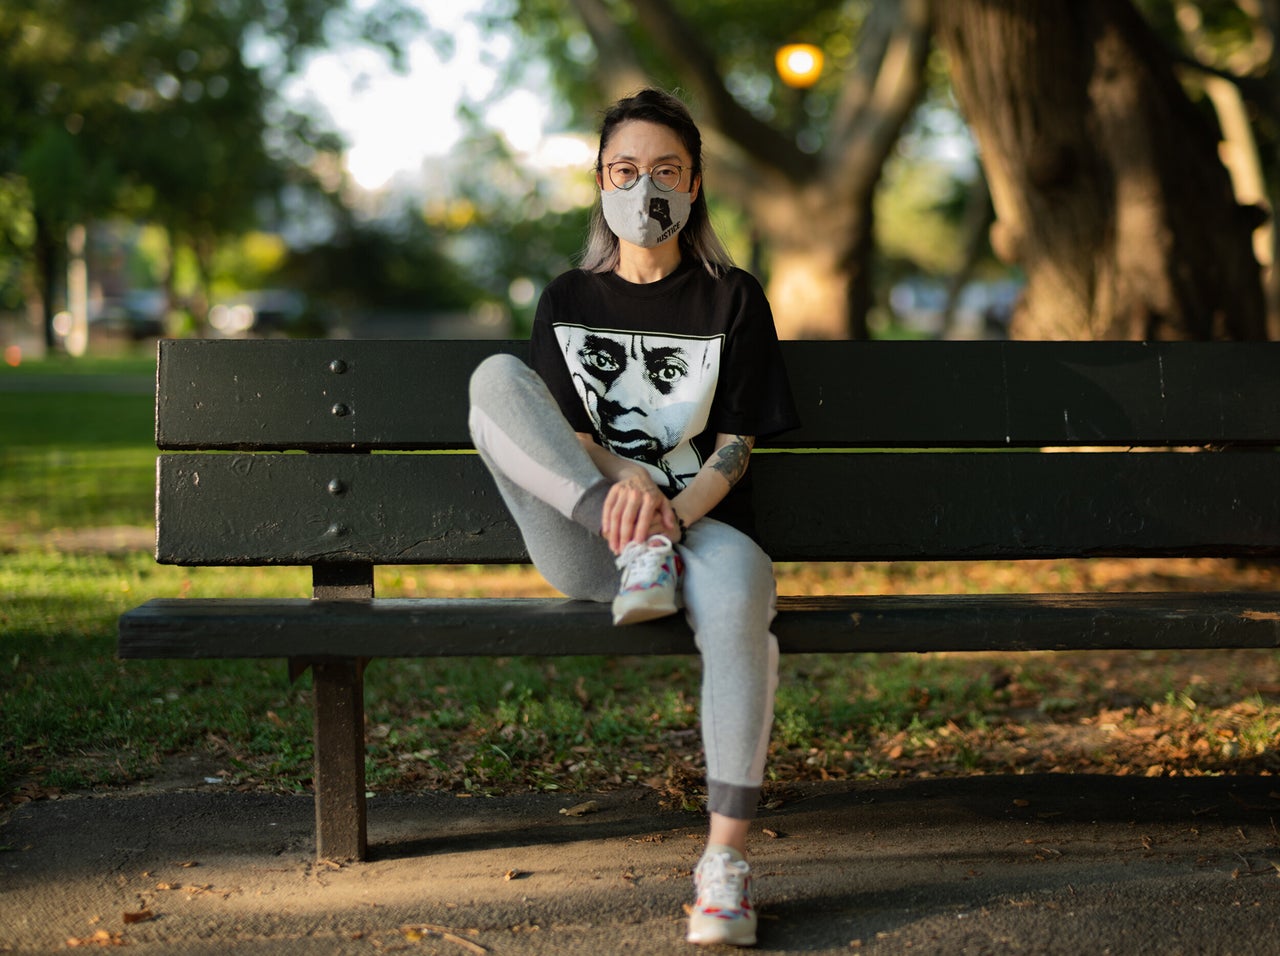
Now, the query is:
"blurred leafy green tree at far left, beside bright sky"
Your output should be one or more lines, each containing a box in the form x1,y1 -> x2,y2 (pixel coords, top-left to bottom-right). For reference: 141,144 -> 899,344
0,0 -> 422,343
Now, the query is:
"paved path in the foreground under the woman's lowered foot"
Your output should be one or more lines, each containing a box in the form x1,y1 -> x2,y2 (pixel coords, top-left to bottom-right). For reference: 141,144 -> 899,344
0,776 -> 1280,956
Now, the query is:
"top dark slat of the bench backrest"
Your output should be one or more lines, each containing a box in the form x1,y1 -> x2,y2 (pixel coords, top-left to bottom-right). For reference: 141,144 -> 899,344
156,340 -> 1280,450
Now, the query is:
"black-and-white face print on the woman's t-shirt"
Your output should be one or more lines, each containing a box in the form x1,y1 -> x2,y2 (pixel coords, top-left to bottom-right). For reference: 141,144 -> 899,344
556,325 -> 722,490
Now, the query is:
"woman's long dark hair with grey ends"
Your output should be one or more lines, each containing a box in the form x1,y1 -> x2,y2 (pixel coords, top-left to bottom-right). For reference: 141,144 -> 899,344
581,88 -> 733,278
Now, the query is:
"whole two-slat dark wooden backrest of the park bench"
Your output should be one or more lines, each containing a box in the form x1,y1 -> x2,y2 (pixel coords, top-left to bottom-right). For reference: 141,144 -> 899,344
156,340 -> 1280,567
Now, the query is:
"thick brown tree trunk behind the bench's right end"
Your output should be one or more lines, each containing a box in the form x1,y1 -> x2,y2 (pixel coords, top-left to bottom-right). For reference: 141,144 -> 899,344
934,0 -> 1266,339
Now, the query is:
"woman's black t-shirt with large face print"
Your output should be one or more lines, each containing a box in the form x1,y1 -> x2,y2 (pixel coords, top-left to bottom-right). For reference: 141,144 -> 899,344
530,259 -> 800,534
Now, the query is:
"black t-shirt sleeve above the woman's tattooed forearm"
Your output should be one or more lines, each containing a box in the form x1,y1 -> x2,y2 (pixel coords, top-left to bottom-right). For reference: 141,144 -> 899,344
710,271 -> 800,438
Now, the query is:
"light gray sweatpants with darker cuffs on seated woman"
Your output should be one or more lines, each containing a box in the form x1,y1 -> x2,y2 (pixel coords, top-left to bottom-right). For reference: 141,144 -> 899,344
470,355 -> 778,819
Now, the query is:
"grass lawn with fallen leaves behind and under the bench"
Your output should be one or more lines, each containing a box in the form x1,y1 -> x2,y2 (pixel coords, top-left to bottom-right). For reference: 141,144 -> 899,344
0,358 -> 1280,806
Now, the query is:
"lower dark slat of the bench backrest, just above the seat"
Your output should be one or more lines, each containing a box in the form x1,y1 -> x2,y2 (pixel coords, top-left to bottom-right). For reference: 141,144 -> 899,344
157,452 -> 1280,566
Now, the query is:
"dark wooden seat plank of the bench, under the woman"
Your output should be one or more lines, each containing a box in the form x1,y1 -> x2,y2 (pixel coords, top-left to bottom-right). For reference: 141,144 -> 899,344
119,593 -> 1280,659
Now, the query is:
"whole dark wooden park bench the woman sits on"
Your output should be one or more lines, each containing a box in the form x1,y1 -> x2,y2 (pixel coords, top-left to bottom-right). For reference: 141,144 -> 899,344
119,340 -> 1280,859
